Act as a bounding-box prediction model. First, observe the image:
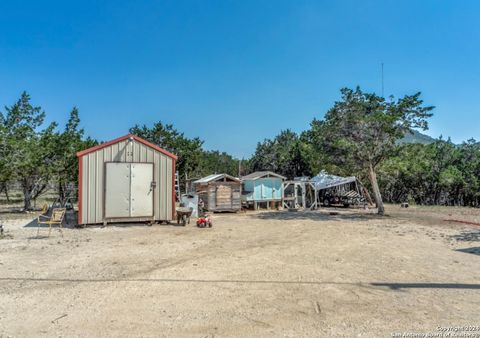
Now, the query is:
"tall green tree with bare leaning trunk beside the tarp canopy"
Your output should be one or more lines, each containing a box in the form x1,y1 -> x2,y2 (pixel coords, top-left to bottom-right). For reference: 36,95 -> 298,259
312,87 -> 433,215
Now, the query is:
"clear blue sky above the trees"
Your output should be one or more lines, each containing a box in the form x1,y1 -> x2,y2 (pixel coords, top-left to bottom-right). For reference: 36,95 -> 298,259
0,0 -> 480,157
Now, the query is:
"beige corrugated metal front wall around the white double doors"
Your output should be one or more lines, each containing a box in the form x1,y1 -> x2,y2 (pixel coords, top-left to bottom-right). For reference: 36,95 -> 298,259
81,140 -> 173,224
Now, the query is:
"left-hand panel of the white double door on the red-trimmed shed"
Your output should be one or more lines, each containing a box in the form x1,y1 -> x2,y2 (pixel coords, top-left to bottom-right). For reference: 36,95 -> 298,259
105,163 -> 130,218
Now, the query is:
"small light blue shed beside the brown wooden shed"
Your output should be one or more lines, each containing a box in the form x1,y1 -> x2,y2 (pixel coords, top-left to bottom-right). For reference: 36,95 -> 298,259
242,171 -> 286,209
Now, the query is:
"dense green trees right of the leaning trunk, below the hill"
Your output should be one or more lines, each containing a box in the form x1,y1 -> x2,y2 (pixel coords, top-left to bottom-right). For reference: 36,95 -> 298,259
378,138 -> 480,206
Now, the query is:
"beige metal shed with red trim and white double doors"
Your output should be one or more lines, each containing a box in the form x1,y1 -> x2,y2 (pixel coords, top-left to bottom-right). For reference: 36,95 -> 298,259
77,134 -> 177,224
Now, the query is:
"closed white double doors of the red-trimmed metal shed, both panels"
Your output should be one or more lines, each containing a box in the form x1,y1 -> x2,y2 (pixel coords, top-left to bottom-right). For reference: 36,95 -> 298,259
105,162 -> 154,218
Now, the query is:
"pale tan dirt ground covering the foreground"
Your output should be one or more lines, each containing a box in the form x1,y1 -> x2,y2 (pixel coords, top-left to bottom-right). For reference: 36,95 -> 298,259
0,206 -> 480,337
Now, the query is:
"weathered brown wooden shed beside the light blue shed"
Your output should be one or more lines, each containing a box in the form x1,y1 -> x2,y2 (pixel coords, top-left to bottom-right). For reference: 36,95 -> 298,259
193,174 -> 242,212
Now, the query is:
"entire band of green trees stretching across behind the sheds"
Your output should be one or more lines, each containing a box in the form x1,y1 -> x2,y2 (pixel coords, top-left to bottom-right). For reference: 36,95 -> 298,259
0,88 -> 480,213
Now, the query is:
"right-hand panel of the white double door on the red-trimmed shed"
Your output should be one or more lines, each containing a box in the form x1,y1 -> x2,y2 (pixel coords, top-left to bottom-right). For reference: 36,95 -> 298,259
130,163 -> 153,217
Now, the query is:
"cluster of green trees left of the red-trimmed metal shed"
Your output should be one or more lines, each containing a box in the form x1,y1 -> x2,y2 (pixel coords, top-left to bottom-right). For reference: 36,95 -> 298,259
0,92 -> 94,210
